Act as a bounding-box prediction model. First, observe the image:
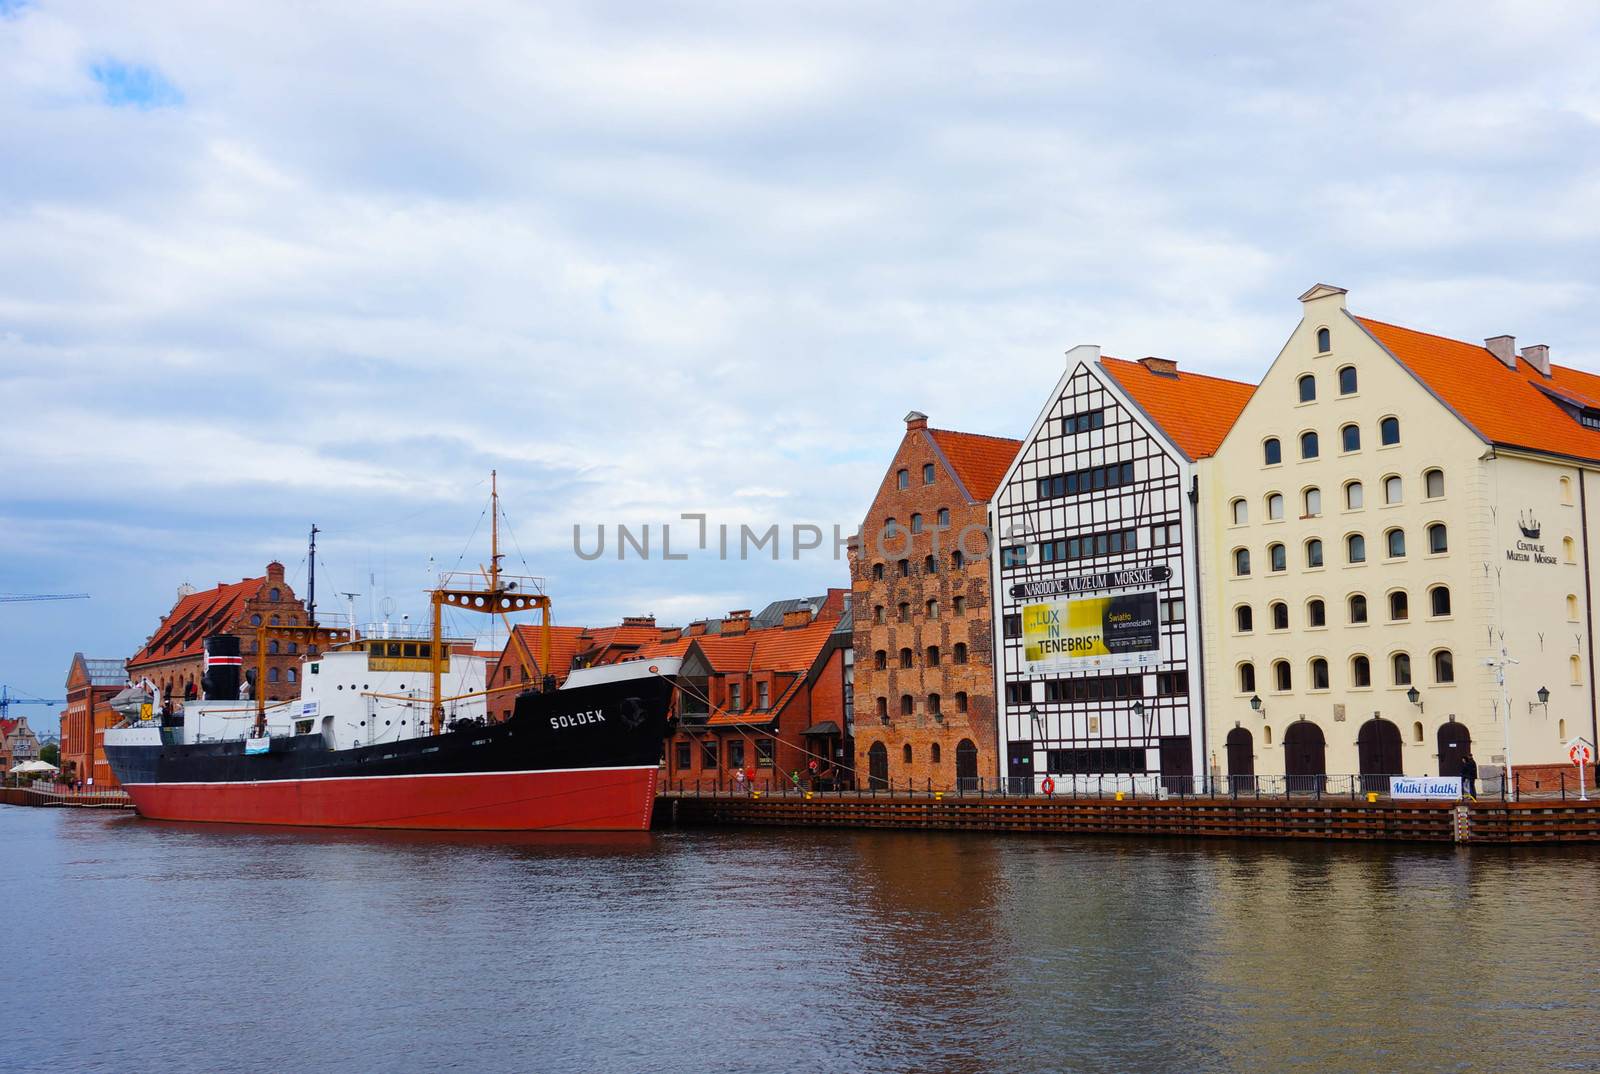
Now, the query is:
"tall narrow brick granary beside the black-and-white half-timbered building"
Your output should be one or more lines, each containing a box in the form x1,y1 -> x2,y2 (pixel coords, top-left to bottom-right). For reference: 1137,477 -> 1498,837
850,411 -> 1021,789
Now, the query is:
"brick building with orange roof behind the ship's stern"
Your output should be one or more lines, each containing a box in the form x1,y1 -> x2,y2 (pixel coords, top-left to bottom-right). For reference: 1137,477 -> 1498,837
128,562 -> 306,701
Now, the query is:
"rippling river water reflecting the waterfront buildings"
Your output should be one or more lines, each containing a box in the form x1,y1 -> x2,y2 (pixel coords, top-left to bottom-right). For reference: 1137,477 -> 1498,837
0,807 -> 1600,1074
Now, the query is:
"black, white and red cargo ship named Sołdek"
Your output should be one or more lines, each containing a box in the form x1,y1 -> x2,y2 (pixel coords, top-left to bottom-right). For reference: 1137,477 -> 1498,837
106,473 -> 678,831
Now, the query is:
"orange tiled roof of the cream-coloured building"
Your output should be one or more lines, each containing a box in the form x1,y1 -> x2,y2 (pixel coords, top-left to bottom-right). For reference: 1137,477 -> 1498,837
1355,317 -> 1600,459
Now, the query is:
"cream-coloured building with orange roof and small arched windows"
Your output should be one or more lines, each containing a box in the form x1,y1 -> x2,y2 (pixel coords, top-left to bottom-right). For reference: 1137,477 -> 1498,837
1198,285 -> 1600,789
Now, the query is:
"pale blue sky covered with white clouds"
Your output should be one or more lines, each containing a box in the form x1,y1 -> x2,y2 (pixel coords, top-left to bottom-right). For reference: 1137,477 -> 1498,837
0,0 -> 1600,710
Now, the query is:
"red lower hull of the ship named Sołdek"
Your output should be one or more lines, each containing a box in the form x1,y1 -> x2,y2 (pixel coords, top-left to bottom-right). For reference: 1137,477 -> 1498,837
123,765 -> 659,832
